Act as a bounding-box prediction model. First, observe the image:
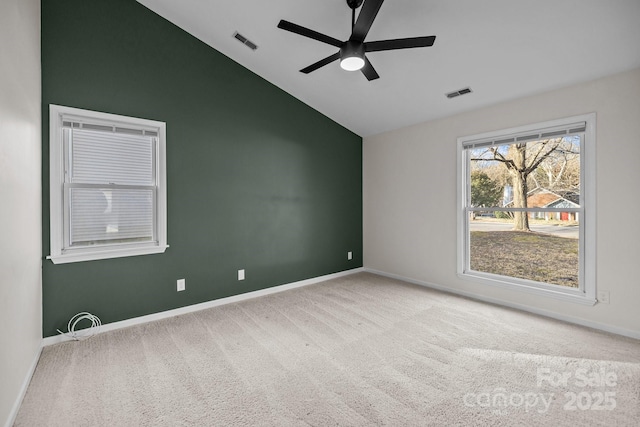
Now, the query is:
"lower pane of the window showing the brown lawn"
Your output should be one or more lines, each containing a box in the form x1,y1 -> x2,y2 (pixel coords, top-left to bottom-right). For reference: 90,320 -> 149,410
469,211 -> 579,288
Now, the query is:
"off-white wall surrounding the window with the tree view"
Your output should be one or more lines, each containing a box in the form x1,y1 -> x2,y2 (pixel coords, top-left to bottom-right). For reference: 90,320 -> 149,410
363,69 -> 640,338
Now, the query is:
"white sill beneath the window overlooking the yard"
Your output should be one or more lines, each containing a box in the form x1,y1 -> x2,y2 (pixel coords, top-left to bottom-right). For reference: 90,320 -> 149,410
458,272 -> 598,305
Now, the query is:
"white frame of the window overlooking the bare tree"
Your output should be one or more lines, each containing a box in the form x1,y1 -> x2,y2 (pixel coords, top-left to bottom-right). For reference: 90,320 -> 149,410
457,113 -> 596,305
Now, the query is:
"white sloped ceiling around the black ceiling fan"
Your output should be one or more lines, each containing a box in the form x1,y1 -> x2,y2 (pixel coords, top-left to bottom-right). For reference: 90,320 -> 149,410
138,0 -> 640,137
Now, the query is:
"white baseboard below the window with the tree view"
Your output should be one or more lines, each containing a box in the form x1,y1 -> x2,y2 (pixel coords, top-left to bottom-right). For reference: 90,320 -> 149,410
364,267 -> 640,339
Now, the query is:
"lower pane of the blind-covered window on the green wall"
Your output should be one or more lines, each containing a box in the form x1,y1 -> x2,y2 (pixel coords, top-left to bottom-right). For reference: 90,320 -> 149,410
70,188 -> 154,247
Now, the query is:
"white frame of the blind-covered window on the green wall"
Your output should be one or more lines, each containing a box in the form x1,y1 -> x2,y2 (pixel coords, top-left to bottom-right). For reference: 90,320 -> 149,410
46,104 -> 169,264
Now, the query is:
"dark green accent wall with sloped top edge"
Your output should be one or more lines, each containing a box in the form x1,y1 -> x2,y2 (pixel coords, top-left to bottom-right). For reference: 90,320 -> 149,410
42,0 -> 362,337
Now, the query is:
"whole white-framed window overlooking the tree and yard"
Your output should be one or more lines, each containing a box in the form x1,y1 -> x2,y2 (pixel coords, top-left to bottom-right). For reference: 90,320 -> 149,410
458,114 -> 596,304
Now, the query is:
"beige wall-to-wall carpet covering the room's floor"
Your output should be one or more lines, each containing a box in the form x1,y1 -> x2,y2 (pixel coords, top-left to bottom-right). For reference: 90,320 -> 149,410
15,273 -> 640,426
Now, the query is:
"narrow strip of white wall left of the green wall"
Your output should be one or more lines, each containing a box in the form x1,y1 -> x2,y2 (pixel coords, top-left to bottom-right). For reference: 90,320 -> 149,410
0,0 -> 42,425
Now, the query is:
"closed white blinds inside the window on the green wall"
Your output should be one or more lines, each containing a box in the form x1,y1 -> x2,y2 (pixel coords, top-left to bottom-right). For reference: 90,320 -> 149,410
63,121 -> 157,248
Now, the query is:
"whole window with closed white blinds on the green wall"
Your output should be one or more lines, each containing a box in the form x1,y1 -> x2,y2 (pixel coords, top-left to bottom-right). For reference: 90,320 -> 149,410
50,105 -> 167,263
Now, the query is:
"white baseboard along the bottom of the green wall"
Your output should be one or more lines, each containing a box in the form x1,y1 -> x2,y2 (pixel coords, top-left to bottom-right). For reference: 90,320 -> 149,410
42,267 -> 364,346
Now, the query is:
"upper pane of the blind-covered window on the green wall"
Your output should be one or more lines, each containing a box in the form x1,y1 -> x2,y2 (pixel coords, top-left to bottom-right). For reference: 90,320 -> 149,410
71,129 -> 154,185
